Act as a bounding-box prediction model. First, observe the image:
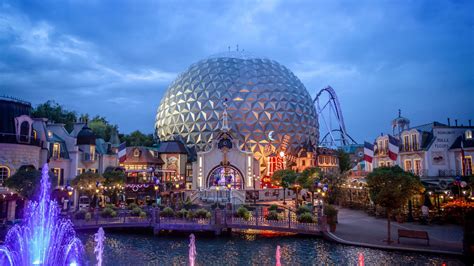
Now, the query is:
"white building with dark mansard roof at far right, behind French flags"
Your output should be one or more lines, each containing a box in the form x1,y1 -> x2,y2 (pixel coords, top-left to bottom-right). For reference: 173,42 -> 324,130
373,111 -> 474,180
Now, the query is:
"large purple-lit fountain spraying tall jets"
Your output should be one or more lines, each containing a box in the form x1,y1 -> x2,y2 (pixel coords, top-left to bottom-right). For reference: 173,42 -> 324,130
0,164 -> 84,266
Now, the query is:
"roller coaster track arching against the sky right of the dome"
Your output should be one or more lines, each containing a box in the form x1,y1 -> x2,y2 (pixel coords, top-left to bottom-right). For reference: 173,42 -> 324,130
313,86 -> 356,148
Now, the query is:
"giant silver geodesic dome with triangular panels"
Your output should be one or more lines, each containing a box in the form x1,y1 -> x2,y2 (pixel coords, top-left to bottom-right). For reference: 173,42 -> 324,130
155,52 -> 319,165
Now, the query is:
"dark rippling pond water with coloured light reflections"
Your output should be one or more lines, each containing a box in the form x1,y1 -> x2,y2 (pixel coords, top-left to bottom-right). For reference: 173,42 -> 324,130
79,232 -> 463,266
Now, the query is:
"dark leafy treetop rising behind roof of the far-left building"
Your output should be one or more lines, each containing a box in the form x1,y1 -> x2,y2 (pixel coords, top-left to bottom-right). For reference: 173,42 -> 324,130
31,100 -> 77,132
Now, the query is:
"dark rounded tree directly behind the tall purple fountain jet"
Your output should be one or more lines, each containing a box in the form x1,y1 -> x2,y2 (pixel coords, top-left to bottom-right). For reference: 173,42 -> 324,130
5,167 -> 55,199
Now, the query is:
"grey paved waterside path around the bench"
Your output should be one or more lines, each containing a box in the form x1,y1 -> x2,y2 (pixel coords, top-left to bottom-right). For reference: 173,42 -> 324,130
330,208 -> 463,254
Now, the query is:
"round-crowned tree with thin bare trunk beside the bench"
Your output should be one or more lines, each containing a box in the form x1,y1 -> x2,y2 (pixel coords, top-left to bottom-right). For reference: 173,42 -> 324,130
366,166 -> 424,243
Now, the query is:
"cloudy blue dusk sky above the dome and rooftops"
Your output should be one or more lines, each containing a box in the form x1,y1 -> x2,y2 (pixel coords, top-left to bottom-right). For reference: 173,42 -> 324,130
0,0 -> 474,142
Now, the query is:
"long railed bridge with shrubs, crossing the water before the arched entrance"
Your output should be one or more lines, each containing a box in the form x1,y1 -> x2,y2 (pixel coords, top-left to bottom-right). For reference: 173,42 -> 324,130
70,208 -> 326,236
